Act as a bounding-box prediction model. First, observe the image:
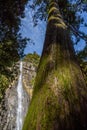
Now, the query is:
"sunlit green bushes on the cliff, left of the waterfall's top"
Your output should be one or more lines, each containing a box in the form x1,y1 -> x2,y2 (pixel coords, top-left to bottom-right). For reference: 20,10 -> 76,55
0,63 -> 19,101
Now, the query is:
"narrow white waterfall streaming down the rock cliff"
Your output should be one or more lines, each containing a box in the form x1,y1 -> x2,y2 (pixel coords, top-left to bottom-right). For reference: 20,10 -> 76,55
16,62 -> 23,130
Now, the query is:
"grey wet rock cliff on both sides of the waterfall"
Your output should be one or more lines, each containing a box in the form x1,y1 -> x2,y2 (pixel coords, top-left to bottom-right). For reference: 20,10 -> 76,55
0,62 -> 36,130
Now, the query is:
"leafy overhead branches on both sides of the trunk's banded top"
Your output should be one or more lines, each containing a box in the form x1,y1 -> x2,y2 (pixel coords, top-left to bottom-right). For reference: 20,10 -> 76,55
30,0 -> 87,43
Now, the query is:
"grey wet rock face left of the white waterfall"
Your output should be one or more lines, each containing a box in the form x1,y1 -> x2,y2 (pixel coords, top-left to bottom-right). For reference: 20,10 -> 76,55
0,82 -> 17,130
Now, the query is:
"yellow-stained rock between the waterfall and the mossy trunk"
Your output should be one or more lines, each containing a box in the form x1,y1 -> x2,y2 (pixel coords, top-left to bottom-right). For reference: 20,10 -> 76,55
23,62 -> 37,100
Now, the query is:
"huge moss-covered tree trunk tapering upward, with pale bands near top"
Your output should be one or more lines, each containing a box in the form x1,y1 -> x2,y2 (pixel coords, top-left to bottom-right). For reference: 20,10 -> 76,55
23,0 -> 87,130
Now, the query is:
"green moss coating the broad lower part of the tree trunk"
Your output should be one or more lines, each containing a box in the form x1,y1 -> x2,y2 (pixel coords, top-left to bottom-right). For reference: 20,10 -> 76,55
23,39 -> 86,130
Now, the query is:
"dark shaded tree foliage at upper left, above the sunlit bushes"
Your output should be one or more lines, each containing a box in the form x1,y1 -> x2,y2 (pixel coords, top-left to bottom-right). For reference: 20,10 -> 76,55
0,0 -> 27,67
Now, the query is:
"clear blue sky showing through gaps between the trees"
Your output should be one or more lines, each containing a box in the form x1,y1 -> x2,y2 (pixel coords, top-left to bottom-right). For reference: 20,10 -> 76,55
20,1 -> 87,55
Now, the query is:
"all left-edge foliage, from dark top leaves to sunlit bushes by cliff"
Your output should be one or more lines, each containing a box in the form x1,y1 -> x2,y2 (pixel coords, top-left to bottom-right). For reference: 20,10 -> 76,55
0,0 -> 27,100
